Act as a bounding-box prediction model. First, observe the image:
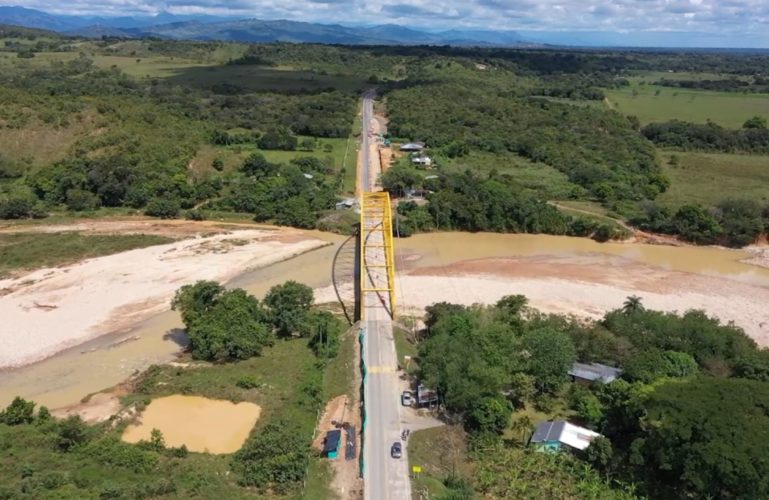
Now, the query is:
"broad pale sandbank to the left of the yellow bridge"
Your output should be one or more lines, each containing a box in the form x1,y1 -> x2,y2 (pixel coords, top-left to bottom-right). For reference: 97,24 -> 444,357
0,227 -> 327,368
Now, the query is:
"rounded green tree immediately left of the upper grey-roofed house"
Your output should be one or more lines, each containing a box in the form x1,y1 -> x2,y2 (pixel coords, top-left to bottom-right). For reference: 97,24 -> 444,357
523,327 -> 577,394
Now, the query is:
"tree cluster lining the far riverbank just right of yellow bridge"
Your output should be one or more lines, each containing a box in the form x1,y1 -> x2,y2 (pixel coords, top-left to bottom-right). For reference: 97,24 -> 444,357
381,166 -> 624,241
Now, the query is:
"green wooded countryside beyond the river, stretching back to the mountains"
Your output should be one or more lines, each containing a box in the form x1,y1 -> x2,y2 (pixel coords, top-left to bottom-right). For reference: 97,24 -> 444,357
0,34 -> 769,244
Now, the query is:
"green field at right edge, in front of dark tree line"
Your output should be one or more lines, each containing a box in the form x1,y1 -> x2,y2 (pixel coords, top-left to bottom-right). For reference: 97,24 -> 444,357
658,152 -> 769,206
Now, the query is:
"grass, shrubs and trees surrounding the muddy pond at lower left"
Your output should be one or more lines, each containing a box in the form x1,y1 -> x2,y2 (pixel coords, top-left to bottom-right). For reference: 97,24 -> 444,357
0,282 -> 349,499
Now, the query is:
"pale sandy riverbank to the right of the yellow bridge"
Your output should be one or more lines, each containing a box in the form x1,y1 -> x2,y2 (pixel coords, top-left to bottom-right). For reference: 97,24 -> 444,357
316,254 -> 769,346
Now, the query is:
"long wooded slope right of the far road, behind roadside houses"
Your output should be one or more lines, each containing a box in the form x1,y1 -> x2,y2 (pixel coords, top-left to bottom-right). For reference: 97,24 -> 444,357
387,80 -> 668,201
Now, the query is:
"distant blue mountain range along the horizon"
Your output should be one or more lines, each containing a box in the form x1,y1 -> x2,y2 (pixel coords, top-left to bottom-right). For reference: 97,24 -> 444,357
0,6 -> 526,46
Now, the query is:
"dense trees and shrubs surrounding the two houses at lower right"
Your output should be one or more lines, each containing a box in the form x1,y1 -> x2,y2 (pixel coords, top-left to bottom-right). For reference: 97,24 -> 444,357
418,296 -> 769,498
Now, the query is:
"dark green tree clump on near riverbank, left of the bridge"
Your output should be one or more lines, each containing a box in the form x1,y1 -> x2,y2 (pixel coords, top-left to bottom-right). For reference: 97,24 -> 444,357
172,281 -> 342,362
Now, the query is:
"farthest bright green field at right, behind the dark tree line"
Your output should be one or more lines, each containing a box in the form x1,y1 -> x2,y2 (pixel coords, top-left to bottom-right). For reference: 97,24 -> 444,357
605,77 -> 769,128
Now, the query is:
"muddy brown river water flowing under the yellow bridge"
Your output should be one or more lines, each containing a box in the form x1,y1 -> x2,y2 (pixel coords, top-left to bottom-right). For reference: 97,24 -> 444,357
0,232 -> 769,408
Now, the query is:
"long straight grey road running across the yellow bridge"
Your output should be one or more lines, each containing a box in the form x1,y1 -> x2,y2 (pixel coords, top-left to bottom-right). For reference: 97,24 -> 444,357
359,92 -> 411,500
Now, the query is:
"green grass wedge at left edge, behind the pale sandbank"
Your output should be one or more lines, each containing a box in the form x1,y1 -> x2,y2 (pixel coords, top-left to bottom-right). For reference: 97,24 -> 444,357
0,232 -> 173,277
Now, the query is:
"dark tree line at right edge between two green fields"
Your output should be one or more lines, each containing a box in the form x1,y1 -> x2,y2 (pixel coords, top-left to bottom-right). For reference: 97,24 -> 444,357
641,117 -> 769,154
